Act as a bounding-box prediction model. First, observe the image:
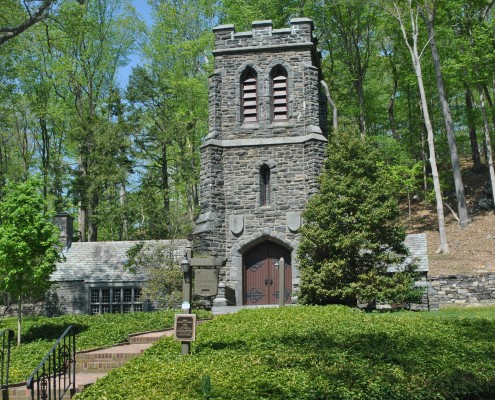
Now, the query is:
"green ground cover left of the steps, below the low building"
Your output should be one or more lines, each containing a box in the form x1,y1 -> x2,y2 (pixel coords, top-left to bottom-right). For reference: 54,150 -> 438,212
0,311 -> 211,383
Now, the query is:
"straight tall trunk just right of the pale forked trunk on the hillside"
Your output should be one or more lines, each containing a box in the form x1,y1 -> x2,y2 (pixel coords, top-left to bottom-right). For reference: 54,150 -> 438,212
420,10 -> 471,228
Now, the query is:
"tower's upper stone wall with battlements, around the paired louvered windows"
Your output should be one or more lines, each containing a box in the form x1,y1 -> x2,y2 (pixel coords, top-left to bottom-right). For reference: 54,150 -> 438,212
208,18 -> 323,140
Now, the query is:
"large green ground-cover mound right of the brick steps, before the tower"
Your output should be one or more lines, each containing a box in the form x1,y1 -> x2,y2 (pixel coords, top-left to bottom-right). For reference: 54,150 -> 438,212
77,306 -> 495,400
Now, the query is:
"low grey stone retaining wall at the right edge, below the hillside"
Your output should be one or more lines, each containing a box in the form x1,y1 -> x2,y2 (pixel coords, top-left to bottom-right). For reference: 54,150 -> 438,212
428,272 -> 495,310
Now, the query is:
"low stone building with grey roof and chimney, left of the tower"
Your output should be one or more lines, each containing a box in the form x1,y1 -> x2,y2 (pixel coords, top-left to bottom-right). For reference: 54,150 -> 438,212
50,213 -> 190,315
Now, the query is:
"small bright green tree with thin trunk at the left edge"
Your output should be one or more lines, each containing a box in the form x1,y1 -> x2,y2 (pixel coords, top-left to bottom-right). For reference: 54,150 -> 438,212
0,178 -> 59,344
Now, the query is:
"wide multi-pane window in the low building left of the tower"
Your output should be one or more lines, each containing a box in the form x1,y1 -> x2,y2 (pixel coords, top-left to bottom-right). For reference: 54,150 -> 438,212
90,288 -> 143,314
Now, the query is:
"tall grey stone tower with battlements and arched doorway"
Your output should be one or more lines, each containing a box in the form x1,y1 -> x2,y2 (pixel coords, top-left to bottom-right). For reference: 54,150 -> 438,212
194,18 -> 327,305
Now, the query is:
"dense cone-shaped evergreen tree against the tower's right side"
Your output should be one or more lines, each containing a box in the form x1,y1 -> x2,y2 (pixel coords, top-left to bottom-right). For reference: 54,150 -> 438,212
298,130 -> 414,305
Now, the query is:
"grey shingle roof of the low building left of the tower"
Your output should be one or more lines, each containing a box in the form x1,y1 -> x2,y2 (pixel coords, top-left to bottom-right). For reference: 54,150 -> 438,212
50,239 -> 189,282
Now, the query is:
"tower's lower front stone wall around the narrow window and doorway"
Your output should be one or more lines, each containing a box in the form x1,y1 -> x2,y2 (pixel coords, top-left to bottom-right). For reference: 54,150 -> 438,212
224,141 -> 325,304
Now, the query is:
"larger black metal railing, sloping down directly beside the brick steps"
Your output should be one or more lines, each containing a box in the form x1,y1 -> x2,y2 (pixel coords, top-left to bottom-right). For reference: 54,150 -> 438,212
27,325 -> 76,400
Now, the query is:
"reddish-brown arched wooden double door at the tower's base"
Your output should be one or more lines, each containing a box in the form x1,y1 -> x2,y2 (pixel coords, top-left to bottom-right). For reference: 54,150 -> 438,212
243,241 -> 292,305
